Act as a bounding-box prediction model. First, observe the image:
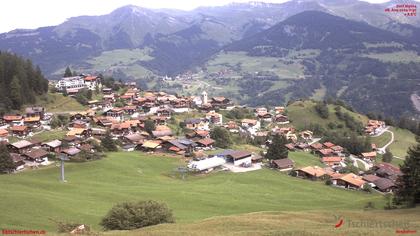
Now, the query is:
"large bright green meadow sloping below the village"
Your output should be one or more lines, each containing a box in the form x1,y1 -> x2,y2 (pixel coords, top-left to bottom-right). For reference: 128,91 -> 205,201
0,152 -> 384,231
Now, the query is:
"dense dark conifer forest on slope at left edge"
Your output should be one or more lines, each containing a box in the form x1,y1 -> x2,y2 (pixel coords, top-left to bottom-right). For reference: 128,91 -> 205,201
0,52 -> 48,113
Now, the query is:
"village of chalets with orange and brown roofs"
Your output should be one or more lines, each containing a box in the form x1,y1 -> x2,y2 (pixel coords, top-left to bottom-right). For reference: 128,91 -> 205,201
0,75 -> 401,192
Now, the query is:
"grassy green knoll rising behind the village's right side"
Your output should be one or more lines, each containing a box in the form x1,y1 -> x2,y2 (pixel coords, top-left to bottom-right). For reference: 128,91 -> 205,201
287,100 -> 368,132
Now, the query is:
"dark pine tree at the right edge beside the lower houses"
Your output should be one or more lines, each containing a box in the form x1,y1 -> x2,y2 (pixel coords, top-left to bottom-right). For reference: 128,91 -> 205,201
394,143 -> 420,207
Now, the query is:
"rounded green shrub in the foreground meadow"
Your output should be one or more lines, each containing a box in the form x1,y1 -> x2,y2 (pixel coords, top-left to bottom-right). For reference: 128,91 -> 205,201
101,200 -> 175,230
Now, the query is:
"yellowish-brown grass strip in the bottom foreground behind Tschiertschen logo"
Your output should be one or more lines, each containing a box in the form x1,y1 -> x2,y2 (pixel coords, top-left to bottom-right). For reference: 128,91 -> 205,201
107,208 -> 420,236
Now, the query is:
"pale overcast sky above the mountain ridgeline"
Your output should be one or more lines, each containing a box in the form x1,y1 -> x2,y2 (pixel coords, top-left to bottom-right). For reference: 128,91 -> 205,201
0,0 -> 414,32
